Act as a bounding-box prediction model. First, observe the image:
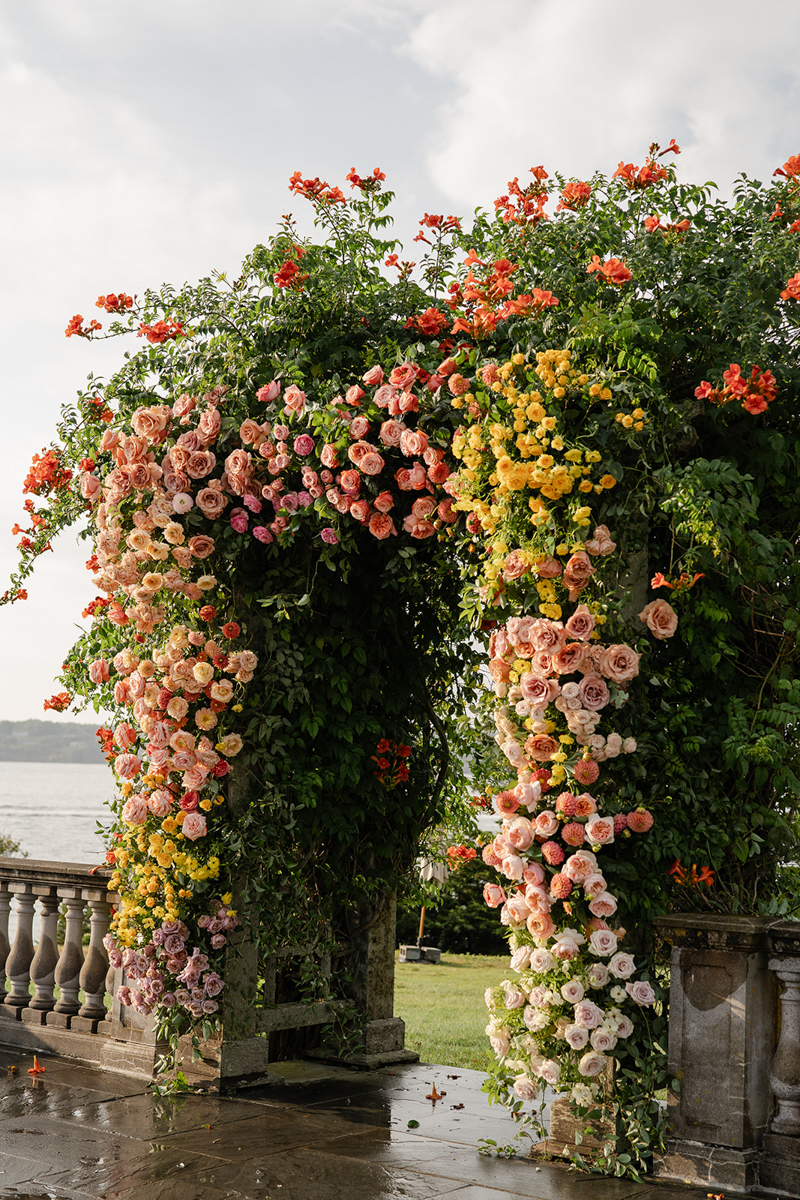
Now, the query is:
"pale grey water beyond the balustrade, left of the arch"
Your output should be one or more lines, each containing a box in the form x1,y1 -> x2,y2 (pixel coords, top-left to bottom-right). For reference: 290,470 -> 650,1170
0,762 -> 114,866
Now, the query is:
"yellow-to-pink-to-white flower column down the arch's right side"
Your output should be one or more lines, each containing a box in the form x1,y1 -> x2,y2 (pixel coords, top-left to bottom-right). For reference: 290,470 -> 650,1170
445,350 -> 676,1156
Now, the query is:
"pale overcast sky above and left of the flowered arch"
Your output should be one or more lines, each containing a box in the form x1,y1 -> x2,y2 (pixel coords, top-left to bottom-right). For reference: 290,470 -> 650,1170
0,0 -> 800,720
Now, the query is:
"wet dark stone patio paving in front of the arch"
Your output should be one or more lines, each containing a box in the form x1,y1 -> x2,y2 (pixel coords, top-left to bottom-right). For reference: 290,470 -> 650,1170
0,1051 -> 763,1200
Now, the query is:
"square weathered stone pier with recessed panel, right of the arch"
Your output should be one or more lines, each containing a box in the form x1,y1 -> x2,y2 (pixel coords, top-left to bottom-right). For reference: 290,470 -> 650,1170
655,913 -> 777,1189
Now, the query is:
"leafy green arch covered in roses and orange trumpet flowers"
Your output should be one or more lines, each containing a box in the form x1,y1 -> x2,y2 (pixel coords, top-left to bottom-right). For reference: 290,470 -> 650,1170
4,143 -> 800,1169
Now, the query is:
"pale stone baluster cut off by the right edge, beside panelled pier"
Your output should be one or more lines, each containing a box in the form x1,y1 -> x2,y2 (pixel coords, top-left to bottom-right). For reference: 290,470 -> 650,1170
760,920 -> 800,1195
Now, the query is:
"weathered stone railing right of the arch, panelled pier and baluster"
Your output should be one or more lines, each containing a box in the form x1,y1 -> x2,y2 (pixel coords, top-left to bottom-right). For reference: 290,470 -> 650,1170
656,913 -> 800,1196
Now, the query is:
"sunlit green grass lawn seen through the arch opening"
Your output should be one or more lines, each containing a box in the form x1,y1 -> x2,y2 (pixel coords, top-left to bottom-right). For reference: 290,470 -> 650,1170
395,954 -> 509,1070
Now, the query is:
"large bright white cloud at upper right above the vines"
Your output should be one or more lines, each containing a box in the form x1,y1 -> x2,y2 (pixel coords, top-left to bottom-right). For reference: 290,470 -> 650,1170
405,0 -> 800,206
